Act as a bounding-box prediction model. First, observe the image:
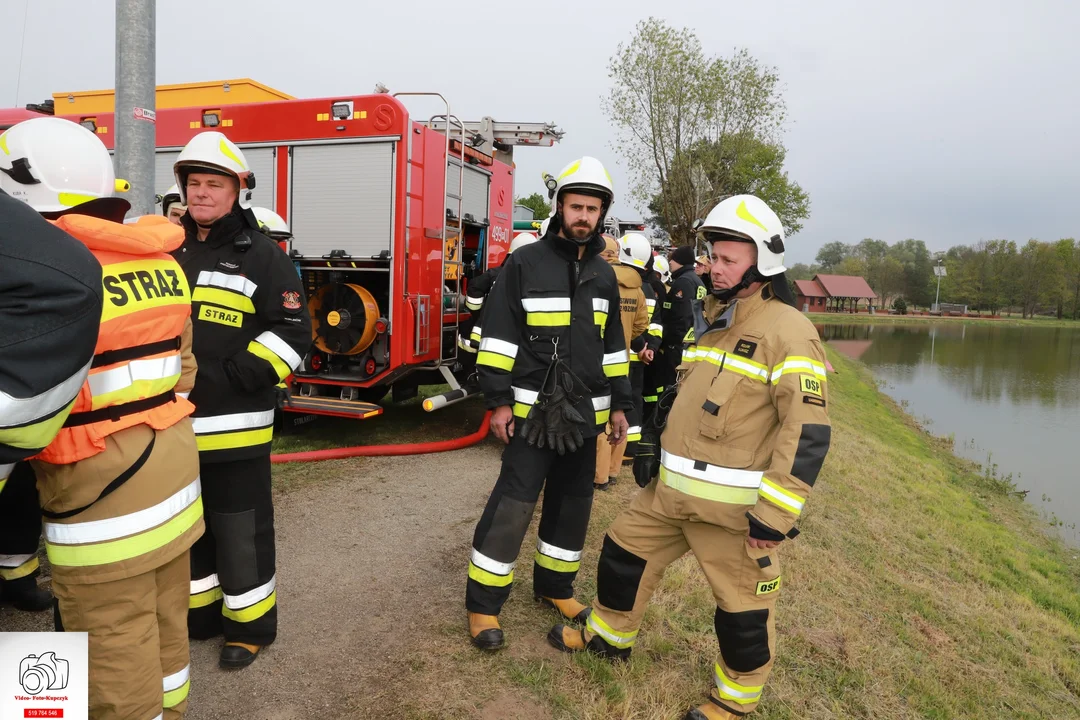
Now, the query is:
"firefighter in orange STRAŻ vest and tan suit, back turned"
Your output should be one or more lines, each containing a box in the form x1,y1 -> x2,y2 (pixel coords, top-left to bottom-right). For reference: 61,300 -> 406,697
0,118 -> 203,720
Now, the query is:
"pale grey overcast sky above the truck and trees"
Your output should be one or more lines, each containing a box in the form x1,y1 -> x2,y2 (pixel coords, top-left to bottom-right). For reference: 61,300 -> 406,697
0,0 -> 1080,262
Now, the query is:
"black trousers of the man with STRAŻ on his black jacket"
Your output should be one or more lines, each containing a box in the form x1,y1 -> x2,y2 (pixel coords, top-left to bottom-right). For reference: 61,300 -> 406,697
188,452 -> 278,646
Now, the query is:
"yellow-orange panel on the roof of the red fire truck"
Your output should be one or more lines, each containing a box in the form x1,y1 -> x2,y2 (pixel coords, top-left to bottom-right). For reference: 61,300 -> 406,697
53,78 -> 296,116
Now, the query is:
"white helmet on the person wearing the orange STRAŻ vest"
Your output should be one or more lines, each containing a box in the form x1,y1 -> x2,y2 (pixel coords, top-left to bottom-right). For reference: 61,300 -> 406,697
0,118 -> 131,213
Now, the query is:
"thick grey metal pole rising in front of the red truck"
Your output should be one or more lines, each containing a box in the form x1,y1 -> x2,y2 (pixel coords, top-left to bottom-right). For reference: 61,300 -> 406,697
114,0 -> 155,217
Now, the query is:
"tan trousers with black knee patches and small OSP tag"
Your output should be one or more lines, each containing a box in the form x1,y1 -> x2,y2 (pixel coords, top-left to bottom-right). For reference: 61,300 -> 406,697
588,480 -> 781,715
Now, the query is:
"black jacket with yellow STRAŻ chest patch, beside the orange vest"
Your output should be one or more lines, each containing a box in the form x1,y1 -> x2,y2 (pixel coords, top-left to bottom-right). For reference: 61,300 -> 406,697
173,213 -> 311,462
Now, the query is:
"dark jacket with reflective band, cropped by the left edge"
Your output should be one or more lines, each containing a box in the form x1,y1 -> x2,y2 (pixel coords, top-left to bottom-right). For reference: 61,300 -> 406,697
0,192 -> 104,470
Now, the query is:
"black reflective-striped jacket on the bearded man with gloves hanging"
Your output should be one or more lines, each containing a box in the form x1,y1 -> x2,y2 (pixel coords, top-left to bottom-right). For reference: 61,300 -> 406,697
476,231 -> 634,435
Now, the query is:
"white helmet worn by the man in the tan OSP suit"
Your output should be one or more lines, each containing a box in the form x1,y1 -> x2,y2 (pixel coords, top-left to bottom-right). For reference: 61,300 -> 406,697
698,195 -> 785,277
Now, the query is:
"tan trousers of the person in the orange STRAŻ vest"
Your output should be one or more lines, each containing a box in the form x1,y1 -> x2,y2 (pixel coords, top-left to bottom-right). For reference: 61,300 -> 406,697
53,552 -> 191,720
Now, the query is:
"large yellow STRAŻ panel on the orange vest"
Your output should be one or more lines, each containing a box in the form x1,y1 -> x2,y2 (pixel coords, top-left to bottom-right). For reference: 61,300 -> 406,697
102,260 -> 191,323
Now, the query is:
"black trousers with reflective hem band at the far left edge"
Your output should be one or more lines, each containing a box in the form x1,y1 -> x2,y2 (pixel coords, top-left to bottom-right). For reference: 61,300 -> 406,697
0,462 -> 41,592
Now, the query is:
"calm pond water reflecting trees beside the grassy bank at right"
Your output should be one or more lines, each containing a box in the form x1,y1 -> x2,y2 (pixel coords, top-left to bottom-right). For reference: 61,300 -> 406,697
818,323 -> 1080,541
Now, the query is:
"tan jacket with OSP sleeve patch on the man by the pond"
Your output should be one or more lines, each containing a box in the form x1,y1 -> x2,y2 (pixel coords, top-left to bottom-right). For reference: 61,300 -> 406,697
654,285 -> 832,540
